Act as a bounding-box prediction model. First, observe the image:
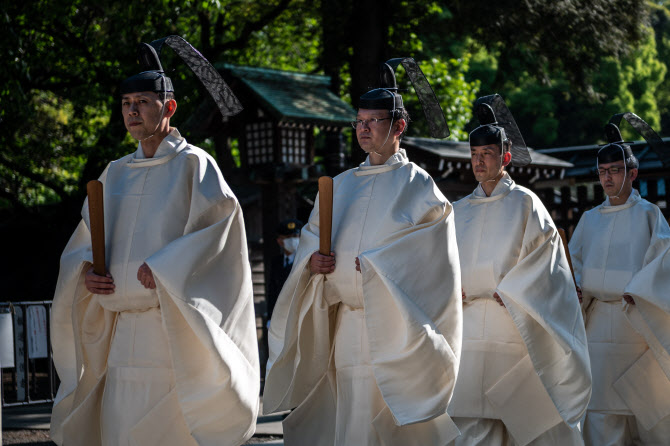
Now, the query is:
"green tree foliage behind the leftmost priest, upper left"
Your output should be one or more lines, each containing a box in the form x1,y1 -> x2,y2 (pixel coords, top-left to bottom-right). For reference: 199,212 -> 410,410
0,0 -> 318,207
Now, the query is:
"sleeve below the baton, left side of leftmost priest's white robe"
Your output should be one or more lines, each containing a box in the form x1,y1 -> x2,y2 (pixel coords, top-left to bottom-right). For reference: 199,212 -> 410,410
51,166 -> 116,445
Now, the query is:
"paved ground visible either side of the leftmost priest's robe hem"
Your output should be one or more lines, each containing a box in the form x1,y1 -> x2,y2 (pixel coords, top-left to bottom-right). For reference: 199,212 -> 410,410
0,404 -> 284,446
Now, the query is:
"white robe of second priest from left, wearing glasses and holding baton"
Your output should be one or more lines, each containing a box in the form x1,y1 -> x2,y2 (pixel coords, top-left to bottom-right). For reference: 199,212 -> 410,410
263,149 -> 462,446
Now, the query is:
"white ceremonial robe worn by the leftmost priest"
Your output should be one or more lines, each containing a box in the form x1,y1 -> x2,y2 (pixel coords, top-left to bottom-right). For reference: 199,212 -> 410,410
51,130 -> 260,446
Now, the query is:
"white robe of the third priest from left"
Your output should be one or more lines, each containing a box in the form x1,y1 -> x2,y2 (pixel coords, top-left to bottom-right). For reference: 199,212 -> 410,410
449,173 -> 591,446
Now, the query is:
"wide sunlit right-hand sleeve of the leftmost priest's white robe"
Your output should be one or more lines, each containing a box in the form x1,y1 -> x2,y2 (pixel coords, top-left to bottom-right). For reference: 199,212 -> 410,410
146,154 -> 260,446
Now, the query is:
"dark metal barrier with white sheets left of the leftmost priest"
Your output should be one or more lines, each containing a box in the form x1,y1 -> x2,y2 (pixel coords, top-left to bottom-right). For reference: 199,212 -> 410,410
0,301 -> 59,407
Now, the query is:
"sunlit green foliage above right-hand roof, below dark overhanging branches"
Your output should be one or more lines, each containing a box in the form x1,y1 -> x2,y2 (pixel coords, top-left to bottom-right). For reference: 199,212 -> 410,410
485,29 -> 667,148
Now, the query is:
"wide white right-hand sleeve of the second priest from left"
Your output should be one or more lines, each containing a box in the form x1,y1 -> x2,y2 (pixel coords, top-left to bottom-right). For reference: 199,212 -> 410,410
360,199 -> 463,426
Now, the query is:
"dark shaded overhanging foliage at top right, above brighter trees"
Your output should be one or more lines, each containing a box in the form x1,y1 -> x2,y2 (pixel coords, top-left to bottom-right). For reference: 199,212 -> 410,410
445,0 -> 646,94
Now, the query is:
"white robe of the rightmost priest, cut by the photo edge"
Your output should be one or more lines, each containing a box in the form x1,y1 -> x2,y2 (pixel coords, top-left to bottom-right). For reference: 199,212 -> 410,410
570,190 -> 670,444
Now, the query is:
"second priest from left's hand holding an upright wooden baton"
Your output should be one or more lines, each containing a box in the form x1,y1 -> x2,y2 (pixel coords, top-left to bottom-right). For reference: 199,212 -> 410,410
309,177 -> 335,274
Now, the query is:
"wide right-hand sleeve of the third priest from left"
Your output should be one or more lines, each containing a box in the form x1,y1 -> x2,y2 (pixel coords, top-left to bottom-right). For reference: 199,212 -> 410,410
497,195 -> 591,426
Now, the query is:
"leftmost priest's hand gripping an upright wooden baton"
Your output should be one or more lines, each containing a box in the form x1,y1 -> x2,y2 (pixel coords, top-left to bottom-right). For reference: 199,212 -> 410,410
84,180 -> 114,294
